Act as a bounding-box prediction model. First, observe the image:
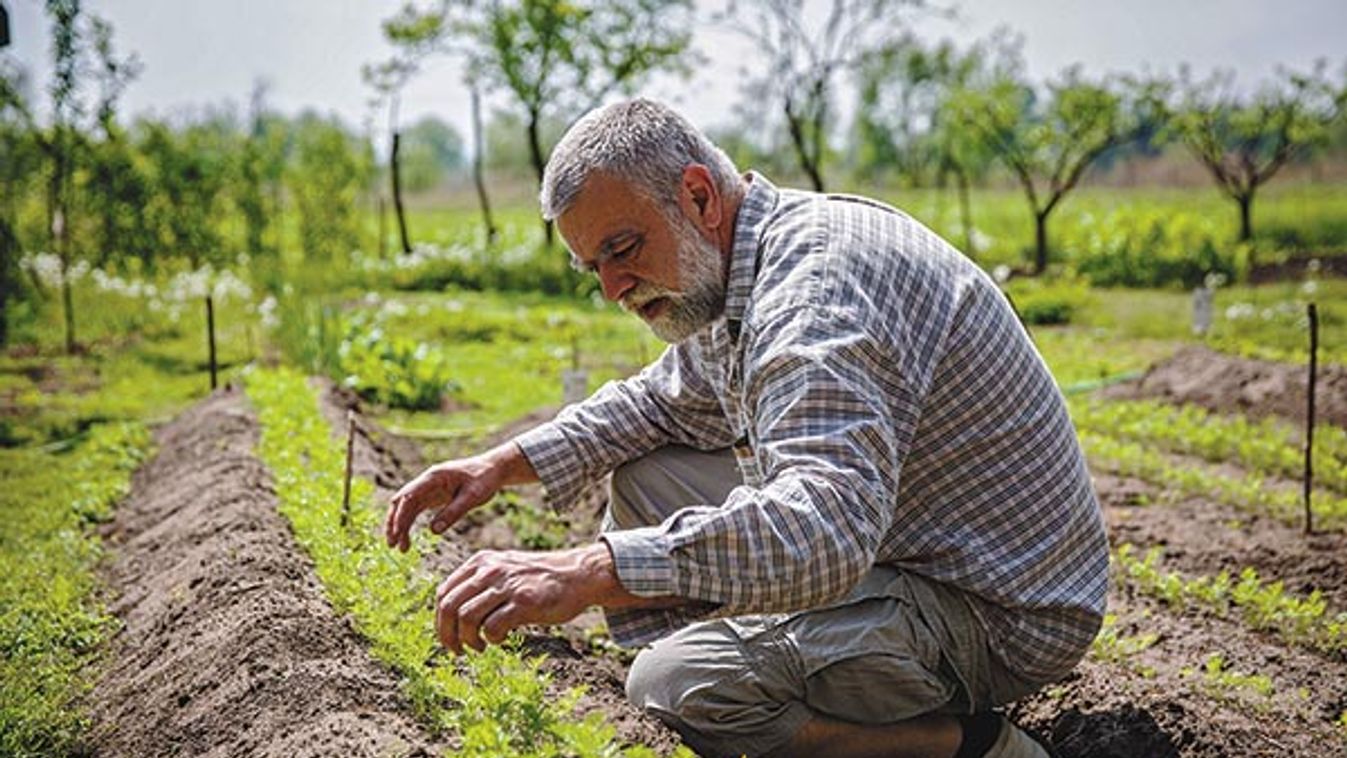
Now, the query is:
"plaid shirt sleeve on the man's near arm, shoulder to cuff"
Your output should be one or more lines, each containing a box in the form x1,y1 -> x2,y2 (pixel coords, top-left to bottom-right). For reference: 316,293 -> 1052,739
603,307 -> 919,642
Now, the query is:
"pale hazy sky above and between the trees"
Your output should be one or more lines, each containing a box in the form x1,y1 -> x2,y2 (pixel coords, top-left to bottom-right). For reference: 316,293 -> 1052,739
0,0 -> 1347,148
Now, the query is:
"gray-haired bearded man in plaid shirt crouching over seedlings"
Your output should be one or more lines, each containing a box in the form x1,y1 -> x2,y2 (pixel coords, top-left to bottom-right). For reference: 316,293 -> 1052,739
387,100 -> 1107,757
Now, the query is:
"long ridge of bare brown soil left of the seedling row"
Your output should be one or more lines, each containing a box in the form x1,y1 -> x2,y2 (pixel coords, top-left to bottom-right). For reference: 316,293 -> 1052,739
90,389 -> 442,757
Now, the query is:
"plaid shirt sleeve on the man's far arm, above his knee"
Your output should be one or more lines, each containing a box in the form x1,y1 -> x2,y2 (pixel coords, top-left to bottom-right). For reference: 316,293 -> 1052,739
515,341 -> 734,509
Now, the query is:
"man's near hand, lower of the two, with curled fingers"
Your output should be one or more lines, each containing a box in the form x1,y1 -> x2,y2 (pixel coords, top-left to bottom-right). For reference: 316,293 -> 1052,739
435,543 -> 630,653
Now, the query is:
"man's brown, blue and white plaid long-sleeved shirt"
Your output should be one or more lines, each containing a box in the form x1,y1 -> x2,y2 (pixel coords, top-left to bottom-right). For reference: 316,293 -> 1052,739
516,174 -> 1109,681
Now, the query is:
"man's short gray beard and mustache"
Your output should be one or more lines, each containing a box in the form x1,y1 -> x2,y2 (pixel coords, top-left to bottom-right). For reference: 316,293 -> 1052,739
622,215 -> 725,345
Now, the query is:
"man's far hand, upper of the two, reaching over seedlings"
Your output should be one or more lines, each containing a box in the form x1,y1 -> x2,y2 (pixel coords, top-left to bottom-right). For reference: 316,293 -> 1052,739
384,442 -> 537,552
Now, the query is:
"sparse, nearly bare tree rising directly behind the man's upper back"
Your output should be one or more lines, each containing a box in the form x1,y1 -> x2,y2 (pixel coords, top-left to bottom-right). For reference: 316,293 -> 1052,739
723,0 -> 925,191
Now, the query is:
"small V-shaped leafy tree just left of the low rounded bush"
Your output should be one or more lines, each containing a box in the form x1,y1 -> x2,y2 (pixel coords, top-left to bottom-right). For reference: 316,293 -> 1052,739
948,67 -> 1164,273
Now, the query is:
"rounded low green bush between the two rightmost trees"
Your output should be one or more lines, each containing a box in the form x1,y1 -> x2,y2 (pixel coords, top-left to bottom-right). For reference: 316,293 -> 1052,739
1060,209 -> 1242,288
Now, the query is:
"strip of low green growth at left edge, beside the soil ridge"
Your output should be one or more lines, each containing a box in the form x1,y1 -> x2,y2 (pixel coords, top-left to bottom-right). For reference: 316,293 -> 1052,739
0,424 -> 150,757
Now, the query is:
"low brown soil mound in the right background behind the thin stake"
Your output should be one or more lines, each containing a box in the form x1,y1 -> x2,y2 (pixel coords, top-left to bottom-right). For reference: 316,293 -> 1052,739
1100,347 -> 1347,427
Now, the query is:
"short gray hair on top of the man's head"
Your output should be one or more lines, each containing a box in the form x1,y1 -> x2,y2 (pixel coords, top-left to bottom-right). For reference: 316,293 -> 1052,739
539,98 -> 740,221
